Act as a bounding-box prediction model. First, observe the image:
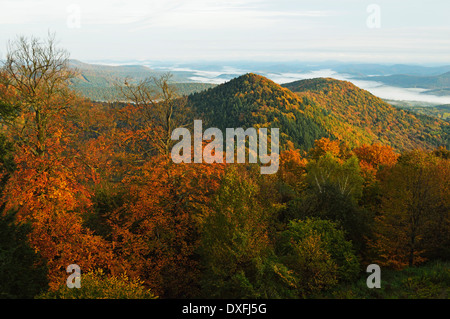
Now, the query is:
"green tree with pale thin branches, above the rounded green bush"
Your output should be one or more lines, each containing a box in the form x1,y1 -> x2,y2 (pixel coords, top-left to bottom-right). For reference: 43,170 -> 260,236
286,153 -> 370,252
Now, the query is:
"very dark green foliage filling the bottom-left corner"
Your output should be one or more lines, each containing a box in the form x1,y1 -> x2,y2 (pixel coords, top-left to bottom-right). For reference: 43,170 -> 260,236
0,212 -> 47,299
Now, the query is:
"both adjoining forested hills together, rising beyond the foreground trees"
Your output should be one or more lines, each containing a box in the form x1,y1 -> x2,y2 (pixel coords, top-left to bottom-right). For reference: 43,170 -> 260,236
185,73 -> 450,151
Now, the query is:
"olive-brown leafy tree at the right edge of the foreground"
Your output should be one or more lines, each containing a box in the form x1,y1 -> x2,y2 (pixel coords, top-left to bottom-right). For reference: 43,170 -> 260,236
373,151 -> 450,268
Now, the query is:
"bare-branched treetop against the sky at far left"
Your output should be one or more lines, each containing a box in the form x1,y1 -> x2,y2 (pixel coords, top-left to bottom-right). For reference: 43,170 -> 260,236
0,34 -> 75,156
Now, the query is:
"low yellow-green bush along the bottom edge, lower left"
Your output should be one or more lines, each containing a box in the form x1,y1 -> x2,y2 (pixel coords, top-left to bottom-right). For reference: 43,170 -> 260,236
37,270 -> 158,299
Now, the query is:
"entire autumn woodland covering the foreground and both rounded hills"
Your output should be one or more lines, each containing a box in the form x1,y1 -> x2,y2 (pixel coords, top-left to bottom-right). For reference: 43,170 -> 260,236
0,38 -> 450,298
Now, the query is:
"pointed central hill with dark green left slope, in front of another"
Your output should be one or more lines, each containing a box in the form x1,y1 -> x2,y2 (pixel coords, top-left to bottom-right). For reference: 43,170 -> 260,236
189,73 -> 333,150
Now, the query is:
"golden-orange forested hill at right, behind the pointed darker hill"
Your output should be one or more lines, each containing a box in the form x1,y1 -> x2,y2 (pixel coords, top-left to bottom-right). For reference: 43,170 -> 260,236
283,78 -> 450,150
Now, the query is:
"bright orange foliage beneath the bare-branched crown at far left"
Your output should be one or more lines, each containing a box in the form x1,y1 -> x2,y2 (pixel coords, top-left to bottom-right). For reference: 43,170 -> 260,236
2,115 -> 108,288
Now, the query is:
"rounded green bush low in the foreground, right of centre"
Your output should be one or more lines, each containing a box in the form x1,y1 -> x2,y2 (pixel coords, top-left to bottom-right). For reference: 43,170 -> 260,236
277,218 -> 359,297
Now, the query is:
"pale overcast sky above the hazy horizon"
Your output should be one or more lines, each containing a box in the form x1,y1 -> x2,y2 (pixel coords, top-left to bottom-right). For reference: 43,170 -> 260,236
0,0 -> 450,64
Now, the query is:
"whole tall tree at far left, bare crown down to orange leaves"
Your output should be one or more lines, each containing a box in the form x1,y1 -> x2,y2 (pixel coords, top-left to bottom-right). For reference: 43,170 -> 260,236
0,36 -> 109,289
